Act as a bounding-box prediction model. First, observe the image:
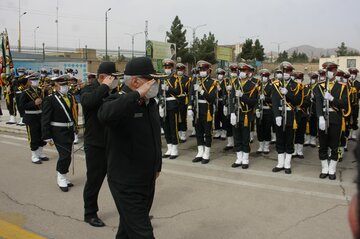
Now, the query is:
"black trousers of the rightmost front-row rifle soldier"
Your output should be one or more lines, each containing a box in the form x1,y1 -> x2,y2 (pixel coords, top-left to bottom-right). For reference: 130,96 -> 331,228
319,123 -> 341,161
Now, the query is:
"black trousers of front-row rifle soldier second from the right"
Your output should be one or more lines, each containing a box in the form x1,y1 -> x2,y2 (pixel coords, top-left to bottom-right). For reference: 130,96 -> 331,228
275,125 -> 295,154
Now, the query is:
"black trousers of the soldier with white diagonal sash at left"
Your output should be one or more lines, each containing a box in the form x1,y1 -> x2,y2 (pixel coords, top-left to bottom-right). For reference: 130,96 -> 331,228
52,126 -> 74,174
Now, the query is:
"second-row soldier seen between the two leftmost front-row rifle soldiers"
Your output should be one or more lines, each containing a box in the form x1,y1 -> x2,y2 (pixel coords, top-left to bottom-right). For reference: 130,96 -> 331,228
174,63 -> 190,143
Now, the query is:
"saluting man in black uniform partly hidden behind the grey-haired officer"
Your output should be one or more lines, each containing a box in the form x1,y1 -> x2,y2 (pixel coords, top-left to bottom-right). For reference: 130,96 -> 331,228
81,62 -> 119,227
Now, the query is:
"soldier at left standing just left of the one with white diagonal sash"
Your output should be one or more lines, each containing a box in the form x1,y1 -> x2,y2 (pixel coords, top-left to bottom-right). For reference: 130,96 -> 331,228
19,73 -> 49,164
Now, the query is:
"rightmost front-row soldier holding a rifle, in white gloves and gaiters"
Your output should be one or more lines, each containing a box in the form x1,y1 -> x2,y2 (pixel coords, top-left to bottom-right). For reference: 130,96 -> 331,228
314,62 -> 349,180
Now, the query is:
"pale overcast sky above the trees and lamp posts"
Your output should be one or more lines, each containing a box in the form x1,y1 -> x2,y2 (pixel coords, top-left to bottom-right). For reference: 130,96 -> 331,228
0,0 -> 360,52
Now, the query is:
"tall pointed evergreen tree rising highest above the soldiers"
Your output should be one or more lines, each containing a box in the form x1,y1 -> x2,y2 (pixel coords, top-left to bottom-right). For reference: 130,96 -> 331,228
166,16 -> 189,62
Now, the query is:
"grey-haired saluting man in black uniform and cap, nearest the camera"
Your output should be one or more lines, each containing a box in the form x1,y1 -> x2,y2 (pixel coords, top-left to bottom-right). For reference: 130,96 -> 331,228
98,57 -> 162,239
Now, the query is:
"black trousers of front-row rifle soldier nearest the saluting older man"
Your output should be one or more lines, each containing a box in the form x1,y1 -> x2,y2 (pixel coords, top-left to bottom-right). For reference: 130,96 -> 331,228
163,108 -> 179,145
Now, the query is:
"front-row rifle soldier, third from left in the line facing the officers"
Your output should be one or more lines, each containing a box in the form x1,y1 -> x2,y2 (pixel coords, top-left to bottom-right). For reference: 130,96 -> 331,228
230,63 -> 258,169
